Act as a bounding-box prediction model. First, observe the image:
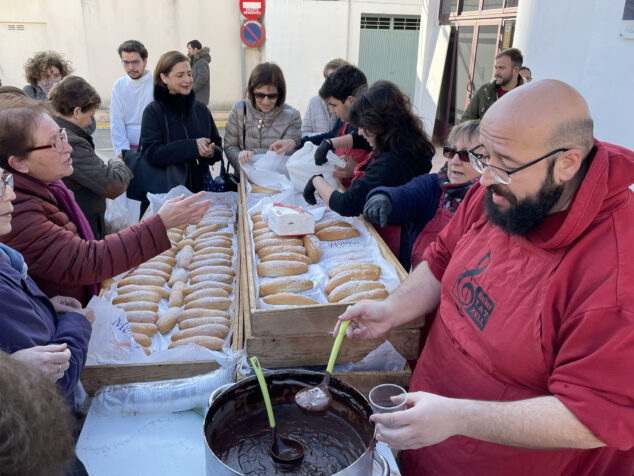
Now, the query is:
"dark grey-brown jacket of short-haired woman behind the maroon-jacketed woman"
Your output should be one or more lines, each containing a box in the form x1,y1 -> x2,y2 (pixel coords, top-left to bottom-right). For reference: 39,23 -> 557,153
55,117 -> 132,240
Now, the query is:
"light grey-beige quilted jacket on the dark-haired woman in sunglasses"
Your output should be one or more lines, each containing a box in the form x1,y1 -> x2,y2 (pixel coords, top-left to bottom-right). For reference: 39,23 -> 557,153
224,99 -> 302,170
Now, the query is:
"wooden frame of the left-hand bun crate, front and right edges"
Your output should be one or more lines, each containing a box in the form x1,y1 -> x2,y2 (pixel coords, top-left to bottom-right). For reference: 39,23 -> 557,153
81,211 -> 244,396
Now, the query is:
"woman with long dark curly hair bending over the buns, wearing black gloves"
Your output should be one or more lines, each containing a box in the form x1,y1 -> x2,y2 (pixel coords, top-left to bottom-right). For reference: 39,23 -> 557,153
304,81 -> 434,262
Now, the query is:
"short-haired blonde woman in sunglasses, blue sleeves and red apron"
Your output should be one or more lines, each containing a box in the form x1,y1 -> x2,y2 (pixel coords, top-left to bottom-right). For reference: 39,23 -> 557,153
363,120 -> 480,269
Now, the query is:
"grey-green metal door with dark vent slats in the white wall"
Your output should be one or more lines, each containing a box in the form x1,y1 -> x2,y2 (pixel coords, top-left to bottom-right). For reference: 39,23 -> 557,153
359,14 -> 420,99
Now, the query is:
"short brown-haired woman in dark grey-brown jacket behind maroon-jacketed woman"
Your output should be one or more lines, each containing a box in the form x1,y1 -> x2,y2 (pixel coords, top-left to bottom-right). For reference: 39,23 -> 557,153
50,76 -> 132,240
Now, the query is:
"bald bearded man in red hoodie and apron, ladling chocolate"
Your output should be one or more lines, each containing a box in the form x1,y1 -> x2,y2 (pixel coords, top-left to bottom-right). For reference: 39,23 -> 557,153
340,80 -> 634,476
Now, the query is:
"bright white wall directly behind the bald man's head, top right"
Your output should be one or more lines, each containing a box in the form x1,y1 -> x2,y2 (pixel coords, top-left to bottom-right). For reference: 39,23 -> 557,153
514,0 -> 634,149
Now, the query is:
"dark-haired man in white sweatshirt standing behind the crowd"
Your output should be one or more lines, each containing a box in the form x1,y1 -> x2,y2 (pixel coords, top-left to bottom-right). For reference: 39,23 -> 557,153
110,40 -> 154,157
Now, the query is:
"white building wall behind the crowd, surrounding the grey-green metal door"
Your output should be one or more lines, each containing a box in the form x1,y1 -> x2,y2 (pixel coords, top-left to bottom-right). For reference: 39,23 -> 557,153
262,0 -> 422,116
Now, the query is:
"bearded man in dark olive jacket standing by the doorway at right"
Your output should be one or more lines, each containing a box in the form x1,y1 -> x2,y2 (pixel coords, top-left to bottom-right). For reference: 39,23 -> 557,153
460,48 -> 526,121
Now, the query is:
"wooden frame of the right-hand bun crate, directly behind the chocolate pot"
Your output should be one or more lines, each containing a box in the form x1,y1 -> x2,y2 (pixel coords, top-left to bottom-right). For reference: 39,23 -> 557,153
239,169 -> 419,370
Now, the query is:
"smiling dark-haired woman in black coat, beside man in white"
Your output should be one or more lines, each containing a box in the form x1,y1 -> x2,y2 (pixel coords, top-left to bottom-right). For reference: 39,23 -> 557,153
134,51 -> 222,203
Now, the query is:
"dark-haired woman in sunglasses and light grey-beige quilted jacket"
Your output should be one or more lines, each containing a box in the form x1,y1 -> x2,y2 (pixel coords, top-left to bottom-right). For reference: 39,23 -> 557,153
224,63 -> 302,170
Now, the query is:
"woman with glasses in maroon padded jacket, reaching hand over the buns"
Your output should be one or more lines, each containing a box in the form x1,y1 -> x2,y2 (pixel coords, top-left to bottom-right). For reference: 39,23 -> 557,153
0,103 -> 210,305
